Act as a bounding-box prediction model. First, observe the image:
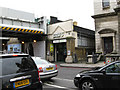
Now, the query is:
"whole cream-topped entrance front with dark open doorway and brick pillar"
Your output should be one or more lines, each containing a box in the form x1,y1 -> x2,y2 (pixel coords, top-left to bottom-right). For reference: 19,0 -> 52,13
47,20 -> 76,63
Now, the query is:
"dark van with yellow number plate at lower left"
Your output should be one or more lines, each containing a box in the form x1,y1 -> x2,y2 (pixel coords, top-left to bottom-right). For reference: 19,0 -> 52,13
0,54 -> 42,90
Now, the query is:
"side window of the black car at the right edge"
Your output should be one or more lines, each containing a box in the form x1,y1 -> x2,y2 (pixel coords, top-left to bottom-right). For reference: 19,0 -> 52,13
106,63 -> 120,73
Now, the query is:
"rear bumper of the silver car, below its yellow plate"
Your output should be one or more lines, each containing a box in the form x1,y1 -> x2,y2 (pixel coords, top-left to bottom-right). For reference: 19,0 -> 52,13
40,70 -> 58,79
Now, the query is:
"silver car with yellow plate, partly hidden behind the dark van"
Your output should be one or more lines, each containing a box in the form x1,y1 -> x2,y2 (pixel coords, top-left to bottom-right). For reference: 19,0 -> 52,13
32,57 -> 58,79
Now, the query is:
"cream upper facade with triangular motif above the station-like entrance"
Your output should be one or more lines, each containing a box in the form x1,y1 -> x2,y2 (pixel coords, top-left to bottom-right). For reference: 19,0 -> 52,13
48,19 -> 78,47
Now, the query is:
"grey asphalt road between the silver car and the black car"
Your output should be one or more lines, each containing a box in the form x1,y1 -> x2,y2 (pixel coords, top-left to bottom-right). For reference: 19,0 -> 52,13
43,66 -> 90,90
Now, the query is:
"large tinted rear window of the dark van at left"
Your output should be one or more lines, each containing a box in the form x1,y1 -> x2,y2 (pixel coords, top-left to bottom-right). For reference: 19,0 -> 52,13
0,57 -> 35,75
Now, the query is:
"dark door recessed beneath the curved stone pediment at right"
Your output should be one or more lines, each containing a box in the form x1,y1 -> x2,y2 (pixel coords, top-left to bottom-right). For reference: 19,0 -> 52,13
103,37 -> 113,54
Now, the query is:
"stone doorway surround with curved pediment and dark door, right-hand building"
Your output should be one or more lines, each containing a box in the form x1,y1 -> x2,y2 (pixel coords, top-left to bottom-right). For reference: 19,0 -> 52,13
98,29 -> 116,54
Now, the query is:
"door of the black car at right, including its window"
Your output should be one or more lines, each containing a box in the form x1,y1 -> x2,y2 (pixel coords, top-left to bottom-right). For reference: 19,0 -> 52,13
103,62 -> 120,88
